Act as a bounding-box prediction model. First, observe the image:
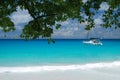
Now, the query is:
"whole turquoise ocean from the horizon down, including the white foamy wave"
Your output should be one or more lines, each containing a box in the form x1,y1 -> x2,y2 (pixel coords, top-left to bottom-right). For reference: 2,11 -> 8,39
0,39 -> 120,73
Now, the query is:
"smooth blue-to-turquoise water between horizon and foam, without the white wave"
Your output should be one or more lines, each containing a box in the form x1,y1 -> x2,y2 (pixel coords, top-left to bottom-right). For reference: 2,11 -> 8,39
0,39 -> 120,66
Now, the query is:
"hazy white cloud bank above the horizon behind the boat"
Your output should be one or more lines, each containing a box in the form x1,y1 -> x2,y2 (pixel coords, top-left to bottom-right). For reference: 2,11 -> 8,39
53,18 -> 120,39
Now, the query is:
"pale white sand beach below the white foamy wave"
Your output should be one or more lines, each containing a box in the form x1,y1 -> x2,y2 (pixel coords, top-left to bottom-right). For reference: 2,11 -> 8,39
0,67 -> 120,80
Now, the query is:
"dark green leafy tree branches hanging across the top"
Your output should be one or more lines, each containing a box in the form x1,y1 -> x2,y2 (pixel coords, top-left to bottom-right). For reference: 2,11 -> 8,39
0,0 -> 120,39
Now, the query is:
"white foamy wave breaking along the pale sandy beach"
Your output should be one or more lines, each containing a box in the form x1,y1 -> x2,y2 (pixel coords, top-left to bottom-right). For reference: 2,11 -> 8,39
0,61 -> 120,73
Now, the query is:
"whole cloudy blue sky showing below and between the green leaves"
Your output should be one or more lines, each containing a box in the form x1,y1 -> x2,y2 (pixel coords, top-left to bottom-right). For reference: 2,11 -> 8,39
0,0 -> 120,39
